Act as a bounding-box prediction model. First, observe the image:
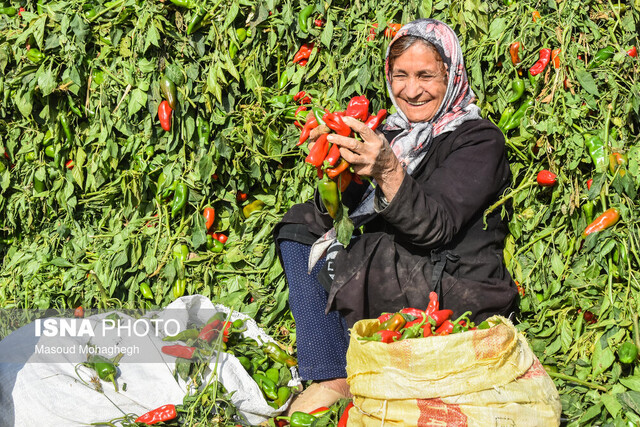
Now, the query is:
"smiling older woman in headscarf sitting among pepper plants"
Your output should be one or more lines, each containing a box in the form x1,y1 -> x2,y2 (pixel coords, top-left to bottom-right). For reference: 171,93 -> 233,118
276,19 -> 517,411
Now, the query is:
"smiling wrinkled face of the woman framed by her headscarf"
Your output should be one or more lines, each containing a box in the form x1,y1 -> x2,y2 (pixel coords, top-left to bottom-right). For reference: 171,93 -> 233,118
391,42 -> 447,123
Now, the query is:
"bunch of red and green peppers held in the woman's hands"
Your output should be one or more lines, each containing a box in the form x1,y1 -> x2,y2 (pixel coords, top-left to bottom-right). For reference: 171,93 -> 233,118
298,95 -> 387,218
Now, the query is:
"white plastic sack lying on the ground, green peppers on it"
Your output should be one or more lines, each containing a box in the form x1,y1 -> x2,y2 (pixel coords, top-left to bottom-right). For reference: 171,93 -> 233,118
0,295 -> 300,426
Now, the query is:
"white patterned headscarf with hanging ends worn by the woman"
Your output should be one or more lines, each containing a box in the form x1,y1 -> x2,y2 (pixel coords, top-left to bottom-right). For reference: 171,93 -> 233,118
309,19 -> 480,270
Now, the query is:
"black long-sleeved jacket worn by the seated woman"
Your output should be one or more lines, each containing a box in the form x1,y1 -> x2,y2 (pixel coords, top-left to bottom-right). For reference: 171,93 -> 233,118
275,120 -> 517,326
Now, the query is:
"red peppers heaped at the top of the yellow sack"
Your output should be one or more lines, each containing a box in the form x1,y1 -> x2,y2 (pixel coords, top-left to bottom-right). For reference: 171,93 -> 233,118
359,292 -> 490,344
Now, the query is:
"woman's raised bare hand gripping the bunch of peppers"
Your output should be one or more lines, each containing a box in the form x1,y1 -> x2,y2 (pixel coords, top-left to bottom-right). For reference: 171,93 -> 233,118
328,116 -> 404,201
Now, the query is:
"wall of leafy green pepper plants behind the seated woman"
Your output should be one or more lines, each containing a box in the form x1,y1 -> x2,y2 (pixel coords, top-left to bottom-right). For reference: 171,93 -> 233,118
0,0 -> 640,425
